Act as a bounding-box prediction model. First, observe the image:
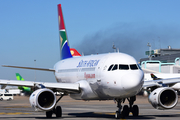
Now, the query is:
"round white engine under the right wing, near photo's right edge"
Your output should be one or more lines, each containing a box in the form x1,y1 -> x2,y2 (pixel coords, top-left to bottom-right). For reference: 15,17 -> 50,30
148,87 -> 178,110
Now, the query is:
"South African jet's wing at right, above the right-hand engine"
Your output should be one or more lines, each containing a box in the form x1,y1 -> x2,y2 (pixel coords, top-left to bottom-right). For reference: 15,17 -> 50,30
143,77 -> 180,87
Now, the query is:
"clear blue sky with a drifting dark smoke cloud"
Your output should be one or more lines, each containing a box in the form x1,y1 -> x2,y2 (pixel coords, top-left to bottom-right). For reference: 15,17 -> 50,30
0,0 -> 180,82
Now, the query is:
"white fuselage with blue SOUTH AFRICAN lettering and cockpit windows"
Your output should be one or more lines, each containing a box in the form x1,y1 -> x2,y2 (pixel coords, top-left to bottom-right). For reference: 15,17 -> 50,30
54,53 -> 144,100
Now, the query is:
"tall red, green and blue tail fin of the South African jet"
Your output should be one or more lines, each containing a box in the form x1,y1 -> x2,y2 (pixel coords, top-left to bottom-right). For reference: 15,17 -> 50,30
58,4 -> 72,59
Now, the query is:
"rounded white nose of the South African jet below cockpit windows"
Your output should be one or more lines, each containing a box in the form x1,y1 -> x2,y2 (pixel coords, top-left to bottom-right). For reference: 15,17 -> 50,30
121,72 -> 144,94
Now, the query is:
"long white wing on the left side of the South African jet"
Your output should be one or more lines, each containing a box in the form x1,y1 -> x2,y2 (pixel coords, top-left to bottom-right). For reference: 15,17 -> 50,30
0,79 -> 80,93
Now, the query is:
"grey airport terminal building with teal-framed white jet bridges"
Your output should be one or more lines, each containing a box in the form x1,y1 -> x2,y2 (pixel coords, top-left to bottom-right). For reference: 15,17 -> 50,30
140,46 -> 180,74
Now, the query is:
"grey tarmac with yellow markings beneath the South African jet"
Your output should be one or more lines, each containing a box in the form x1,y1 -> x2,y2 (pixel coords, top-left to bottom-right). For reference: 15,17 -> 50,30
0,96 -> 180,120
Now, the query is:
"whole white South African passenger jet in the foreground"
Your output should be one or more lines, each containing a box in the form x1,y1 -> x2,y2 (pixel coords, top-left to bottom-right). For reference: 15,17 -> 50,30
0,4 -> 180,118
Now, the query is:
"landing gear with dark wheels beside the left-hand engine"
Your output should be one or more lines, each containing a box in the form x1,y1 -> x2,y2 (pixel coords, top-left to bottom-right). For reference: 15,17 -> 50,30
46,94 -> 64,118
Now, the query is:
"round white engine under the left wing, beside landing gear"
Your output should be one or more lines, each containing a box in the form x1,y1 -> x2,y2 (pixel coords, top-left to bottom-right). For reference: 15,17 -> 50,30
29,88 -> 56,111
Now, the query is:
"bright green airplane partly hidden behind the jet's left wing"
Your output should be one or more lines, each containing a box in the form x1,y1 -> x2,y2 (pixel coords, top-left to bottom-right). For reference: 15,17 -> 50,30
16,73 -> 32,94
